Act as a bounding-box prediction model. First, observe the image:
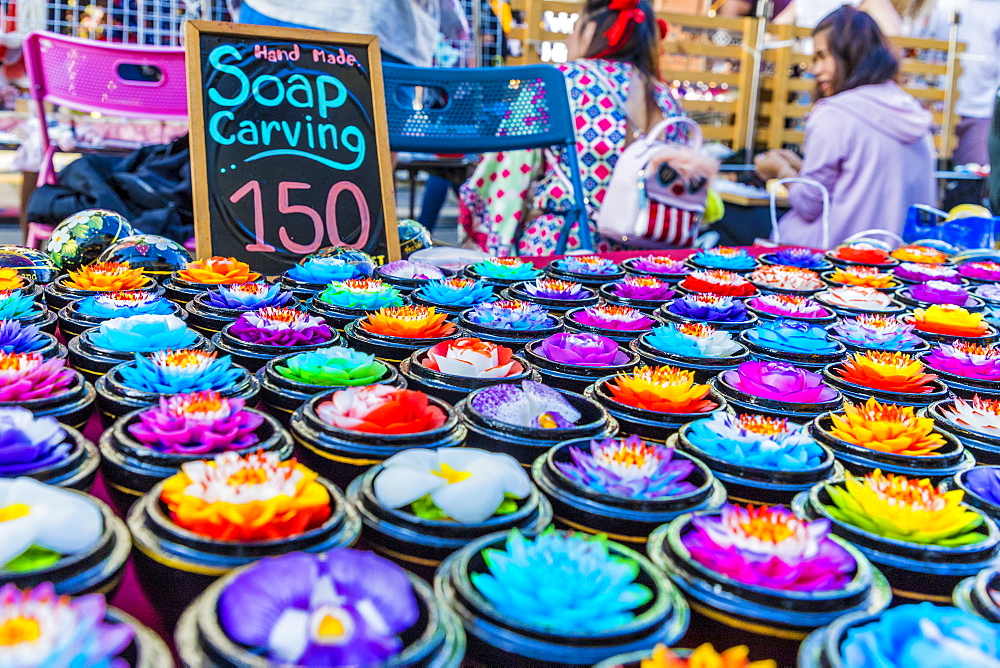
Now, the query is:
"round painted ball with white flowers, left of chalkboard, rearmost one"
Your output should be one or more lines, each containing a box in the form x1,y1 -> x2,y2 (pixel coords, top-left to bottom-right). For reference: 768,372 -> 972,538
45,209 -> 135,271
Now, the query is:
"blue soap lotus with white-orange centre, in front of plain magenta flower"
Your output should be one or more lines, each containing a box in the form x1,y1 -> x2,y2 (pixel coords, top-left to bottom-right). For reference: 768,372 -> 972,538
685,412 -> 826,471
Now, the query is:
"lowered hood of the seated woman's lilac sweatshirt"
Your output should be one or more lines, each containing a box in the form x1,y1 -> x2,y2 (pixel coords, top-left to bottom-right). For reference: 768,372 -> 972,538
816,81 -> 934,144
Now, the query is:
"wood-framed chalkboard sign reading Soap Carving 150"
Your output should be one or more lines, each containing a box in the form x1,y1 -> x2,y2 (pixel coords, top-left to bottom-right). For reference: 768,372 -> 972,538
185,21 -> 399,276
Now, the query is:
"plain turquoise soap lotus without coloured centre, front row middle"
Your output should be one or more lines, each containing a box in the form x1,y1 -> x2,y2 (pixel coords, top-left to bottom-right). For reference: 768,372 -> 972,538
469,528 -> 653,633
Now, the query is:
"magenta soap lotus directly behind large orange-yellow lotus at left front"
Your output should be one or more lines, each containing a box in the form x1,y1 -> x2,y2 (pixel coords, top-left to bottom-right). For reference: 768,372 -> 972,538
128,390 -> 264,455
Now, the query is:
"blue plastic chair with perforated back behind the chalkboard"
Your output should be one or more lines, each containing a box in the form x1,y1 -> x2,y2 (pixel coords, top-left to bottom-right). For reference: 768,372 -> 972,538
382,63 -> 594,255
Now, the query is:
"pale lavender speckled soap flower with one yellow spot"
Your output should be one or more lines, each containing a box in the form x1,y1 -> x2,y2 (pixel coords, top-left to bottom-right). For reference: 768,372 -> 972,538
469,380 -> 581,429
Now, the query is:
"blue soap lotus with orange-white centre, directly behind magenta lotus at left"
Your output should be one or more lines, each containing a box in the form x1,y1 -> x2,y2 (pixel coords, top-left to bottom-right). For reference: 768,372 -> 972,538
118,348 -> 243,394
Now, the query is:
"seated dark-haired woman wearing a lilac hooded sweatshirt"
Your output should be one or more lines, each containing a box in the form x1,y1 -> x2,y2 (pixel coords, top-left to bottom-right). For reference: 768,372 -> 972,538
754,6 -> 937,248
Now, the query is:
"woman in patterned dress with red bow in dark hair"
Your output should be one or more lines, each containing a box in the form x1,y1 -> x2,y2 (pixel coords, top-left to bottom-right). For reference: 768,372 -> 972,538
459,0 -> 683,256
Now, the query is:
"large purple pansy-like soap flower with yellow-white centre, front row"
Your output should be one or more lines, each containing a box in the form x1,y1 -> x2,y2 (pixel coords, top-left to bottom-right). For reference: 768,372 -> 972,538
218,548 -> 420,666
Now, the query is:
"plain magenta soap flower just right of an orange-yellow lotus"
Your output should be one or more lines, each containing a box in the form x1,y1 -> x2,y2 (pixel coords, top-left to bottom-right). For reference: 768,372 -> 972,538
722,362 -> 838,404
